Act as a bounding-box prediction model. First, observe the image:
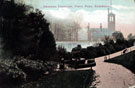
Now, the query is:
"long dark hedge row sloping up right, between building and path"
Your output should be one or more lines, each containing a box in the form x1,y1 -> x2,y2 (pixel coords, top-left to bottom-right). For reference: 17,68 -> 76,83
69,36 -> 135,59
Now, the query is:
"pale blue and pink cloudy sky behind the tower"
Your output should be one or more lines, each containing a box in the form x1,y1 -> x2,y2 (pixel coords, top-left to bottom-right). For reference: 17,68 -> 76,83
22,0 -> 135,37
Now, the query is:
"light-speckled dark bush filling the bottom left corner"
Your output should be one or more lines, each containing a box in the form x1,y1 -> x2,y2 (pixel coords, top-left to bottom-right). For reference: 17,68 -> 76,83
0,59 -> 27,85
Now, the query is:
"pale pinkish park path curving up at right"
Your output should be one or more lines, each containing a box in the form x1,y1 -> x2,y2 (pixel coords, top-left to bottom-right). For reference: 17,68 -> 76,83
93,47 -> 135,88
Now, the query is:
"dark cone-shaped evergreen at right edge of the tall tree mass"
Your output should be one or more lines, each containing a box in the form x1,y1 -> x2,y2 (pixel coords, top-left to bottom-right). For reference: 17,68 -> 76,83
38,31 -> 56,60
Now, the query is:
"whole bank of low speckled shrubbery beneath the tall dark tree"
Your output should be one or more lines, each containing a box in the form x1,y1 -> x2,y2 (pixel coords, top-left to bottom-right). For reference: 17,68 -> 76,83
0,57 -> 53,88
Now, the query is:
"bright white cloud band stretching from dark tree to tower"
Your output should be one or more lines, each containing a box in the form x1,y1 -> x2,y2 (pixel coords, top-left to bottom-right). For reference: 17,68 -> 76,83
43,8 -> 107,27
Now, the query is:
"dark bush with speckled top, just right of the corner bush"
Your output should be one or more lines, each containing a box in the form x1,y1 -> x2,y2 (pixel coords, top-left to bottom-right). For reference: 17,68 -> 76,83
14,57 -> 49,80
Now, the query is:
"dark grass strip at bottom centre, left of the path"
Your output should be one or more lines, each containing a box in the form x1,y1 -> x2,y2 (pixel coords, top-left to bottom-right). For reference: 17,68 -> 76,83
21,70 -> 95,88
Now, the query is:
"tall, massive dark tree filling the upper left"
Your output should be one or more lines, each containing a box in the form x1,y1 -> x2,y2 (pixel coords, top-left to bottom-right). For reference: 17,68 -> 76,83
0,1 -> 56,60
